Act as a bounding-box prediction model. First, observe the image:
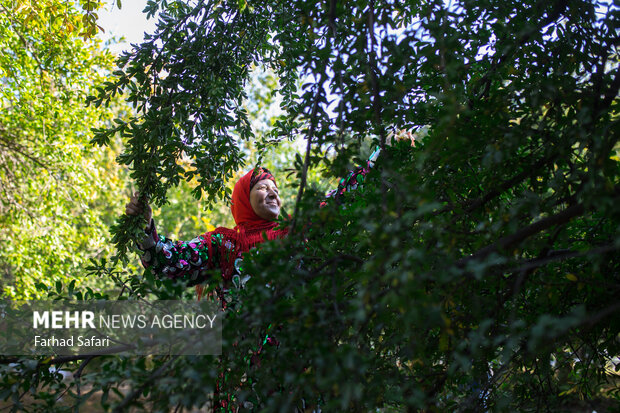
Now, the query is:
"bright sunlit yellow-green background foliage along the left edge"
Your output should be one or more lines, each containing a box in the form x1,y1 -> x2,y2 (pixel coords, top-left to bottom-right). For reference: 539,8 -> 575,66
0,1 -> 126,298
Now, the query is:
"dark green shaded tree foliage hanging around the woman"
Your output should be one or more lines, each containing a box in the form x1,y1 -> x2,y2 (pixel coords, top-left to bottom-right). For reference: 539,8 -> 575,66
3,0 -> 620,412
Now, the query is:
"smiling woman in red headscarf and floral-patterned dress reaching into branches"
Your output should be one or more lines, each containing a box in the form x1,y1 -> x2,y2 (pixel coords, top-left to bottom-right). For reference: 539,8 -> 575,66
125,168 -> 288,307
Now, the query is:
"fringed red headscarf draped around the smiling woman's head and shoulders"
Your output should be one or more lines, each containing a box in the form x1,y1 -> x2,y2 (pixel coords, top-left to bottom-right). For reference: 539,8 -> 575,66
196,168 -> 288,299
